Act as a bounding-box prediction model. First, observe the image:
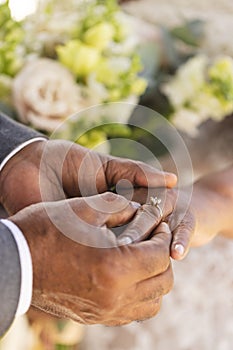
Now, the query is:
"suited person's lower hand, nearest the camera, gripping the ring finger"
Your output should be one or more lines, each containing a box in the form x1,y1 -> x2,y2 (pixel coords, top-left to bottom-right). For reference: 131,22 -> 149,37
10,193 -> 173,326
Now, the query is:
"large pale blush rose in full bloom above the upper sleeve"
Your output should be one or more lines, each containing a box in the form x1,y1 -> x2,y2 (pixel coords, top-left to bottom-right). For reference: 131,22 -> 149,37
13,58 -> 86,132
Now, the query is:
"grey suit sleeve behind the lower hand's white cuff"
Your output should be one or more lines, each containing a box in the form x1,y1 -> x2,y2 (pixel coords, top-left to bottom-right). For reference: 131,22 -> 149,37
0,222 -> 21,337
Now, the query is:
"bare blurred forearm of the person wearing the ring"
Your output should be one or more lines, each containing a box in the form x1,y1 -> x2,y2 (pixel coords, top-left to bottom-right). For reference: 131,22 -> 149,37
191,166 -> 233,246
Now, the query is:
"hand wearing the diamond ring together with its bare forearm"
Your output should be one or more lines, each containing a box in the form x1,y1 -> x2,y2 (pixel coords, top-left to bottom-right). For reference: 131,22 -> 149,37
120,166 -> 233,260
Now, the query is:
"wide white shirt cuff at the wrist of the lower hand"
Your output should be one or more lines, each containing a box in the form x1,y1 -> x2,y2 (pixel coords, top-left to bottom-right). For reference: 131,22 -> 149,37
1,219 -> 33,316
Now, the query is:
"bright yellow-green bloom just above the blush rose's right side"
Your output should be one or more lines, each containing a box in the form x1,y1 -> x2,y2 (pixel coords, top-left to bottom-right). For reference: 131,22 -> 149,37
56,40 -> 100,77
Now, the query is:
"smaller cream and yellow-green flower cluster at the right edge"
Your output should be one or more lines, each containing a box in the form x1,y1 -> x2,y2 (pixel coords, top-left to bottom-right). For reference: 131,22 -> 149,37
163,55 -> 233,136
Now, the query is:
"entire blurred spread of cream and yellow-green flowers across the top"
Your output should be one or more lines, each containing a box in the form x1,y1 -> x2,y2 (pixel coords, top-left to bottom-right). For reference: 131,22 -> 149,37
0,0 -> 233,147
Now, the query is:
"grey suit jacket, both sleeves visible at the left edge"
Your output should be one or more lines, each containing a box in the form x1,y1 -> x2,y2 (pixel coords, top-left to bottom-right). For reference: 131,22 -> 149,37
0,113 -> 41,336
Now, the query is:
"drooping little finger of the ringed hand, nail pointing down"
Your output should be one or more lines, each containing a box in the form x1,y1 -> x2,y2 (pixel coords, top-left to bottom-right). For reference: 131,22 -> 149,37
168,212 -> 195,260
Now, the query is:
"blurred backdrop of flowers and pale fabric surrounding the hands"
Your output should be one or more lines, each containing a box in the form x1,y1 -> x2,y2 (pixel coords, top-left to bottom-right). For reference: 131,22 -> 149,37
0,0 -> 233,350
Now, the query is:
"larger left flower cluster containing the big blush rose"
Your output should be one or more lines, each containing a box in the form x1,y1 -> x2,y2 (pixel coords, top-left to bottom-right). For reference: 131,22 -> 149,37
0,0 -> 147,146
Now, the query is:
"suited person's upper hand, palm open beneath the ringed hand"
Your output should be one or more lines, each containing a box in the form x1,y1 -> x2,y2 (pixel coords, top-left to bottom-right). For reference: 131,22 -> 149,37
0,140 -> 176,214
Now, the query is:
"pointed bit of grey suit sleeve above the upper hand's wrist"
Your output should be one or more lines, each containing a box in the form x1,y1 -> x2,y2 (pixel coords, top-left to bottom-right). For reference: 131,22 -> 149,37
0,112 -> 44,164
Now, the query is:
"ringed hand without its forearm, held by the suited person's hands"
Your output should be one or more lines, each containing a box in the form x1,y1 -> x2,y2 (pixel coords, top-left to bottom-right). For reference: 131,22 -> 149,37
118,188 -> 196,260
